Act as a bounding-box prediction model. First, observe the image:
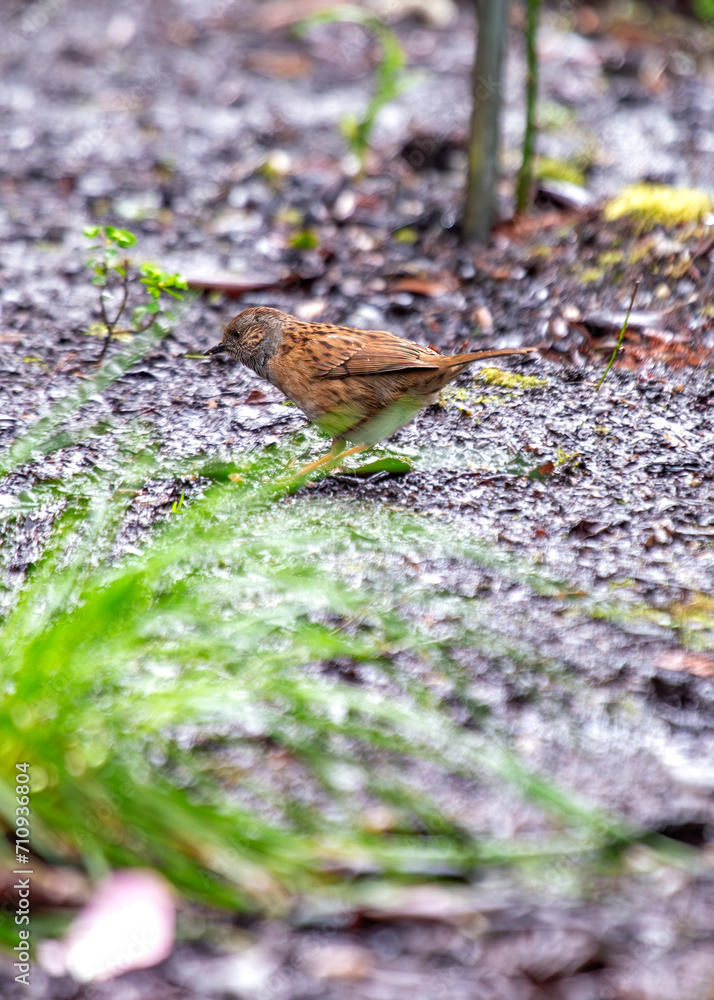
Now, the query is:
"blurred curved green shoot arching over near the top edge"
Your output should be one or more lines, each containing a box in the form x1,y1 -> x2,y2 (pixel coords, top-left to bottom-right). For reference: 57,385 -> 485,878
296,4 -> 409,170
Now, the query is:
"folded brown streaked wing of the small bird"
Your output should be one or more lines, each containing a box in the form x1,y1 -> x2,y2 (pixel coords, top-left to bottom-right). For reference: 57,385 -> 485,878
314,330 -> 439,378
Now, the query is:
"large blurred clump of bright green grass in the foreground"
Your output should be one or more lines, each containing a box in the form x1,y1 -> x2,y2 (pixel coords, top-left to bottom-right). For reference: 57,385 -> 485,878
0,454 -> 615,936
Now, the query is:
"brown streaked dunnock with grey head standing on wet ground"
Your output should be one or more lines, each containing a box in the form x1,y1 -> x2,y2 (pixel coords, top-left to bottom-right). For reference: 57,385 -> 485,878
206,306 -> 536,474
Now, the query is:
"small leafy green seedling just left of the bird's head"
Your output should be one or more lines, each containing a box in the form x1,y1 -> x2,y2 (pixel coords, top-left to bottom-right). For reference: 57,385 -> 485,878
84,226 -> 187,363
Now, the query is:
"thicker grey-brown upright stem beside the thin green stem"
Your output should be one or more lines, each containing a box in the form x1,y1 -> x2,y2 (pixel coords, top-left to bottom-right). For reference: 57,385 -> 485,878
464,0 -> 510,243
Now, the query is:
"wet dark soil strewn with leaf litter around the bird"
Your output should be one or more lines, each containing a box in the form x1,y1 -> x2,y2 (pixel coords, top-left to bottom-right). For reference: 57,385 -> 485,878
0,2 -> 714,1000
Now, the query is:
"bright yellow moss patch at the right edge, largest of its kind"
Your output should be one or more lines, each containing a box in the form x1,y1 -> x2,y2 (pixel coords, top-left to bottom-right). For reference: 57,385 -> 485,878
603,184 -> 712,232
